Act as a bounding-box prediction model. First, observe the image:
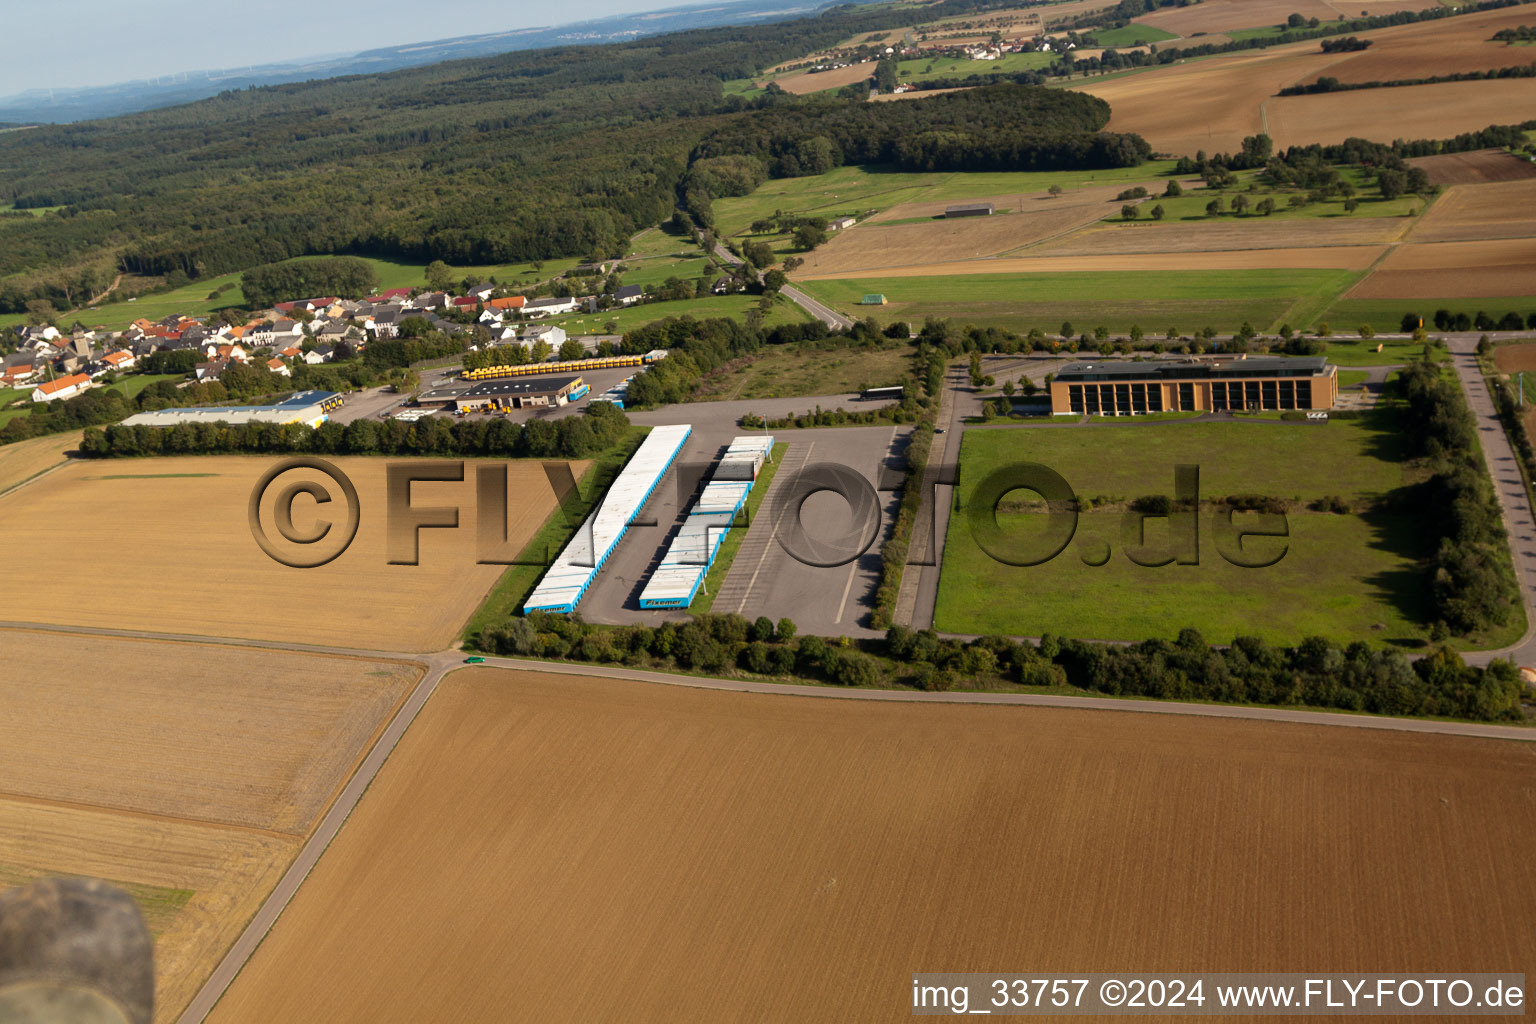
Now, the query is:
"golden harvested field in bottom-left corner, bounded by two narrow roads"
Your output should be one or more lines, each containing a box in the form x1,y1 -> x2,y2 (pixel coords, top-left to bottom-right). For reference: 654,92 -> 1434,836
0,629 -> 419,1022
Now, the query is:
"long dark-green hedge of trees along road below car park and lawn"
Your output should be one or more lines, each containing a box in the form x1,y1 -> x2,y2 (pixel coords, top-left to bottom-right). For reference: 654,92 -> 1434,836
478,613 -> 1524,722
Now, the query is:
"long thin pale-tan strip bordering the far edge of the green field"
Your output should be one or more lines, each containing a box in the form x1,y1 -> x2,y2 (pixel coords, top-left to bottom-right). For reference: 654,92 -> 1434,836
794,246 -> 1385,281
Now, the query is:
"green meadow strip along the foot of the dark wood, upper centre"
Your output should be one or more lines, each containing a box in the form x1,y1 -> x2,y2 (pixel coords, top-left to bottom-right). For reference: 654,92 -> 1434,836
714,160 -> 1174,236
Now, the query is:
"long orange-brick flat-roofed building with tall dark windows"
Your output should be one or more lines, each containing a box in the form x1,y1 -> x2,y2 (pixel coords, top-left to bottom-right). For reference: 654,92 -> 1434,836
1051,356 -> 1338,416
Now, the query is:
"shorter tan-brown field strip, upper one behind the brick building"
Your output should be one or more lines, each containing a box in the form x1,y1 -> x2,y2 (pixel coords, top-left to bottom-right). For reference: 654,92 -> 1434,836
1031,216 -> 1413,256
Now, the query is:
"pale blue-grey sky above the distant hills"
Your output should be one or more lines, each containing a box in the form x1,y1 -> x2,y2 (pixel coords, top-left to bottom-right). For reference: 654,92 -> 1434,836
0,0 -> 679,95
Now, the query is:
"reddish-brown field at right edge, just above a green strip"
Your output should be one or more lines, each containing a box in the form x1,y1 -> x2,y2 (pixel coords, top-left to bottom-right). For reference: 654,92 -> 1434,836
1346,238 -> 1536,299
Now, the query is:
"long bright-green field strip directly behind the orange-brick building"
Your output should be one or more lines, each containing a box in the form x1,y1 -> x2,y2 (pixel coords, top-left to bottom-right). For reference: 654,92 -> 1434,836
797,270 -> 1359,333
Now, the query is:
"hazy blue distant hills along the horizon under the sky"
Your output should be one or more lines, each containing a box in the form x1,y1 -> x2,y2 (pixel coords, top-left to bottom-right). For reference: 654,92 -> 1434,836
0,0 -> 854,127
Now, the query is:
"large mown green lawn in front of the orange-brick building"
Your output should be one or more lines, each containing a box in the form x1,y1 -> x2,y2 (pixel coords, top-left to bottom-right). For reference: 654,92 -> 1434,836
935,413 -> 1456,646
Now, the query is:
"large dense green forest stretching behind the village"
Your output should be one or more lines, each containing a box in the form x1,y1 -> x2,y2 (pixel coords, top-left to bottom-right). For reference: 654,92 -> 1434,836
0,0 -> 1142,312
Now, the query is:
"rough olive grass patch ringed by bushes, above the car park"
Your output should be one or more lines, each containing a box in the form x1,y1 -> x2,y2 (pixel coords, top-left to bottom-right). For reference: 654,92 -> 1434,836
697,341 -> 912,401
